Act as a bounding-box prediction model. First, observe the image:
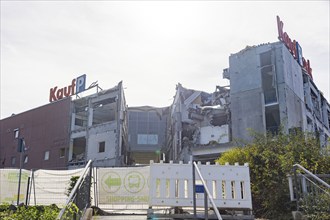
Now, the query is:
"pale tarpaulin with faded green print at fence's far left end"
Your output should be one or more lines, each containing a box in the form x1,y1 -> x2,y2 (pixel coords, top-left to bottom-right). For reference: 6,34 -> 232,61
0,169 -> 30,204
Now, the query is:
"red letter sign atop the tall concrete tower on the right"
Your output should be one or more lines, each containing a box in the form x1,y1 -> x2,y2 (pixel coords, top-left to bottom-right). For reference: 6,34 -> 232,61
277,16 -> 313,79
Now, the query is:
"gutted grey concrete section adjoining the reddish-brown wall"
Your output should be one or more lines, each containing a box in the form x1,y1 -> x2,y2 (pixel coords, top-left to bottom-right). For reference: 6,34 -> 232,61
69,82 -> 128,167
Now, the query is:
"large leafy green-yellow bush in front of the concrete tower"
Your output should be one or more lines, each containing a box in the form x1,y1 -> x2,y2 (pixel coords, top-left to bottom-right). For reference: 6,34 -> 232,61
217,131 -> 330,219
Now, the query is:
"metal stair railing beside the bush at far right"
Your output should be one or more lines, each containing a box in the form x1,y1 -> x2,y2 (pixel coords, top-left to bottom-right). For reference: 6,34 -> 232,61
288,164 -> 330,210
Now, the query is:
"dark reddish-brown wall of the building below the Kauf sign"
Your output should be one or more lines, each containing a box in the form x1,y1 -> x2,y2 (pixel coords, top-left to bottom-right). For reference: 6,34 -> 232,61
0,98 -> 71,169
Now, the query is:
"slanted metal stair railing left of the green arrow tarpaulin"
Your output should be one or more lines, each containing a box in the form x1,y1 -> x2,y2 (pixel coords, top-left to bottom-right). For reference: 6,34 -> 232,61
57,160 -> 92,220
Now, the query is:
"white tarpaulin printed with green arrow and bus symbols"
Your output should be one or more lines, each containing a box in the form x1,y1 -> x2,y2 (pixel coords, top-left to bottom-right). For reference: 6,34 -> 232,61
97,167 -> 150,205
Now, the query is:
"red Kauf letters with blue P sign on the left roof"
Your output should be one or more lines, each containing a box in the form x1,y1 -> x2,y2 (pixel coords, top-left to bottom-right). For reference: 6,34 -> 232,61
49,74 -> 86,102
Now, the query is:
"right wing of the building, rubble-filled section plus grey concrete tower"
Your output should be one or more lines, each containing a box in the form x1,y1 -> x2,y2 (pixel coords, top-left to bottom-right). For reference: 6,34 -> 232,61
162,41 -> 330,161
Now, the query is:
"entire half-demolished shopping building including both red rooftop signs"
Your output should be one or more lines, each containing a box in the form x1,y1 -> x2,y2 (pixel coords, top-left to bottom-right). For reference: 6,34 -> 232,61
0,32 -> 330,169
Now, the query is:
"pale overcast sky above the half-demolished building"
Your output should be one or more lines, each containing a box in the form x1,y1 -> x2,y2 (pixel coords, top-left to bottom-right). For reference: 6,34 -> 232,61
0,0 -> 330,118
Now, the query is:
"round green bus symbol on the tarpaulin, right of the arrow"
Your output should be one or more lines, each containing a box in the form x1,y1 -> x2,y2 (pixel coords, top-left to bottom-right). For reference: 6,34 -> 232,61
124,171 -> 145,193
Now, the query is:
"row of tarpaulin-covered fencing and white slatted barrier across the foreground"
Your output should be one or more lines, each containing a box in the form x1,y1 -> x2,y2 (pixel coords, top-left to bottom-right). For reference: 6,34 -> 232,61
0,162 -> 252,210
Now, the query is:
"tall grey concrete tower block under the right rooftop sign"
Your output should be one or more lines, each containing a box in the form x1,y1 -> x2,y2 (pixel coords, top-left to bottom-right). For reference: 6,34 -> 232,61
223,42 -> 330,146
